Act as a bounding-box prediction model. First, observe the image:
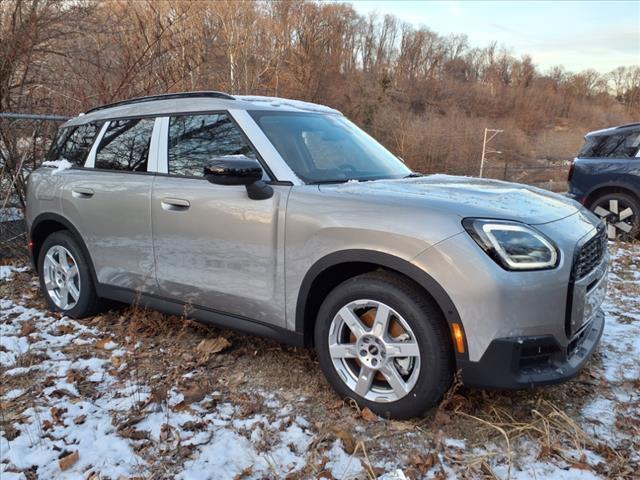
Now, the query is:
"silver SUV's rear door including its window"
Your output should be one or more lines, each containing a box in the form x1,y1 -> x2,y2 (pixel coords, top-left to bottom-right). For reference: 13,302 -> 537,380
62,118 -> 157,292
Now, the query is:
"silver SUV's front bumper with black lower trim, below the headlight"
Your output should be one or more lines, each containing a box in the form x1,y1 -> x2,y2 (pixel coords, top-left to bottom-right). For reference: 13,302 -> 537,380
414,209 -> 609,389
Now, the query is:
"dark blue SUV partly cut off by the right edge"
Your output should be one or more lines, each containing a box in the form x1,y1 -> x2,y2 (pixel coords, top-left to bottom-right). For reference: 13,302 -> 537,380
569,123 -> 640,240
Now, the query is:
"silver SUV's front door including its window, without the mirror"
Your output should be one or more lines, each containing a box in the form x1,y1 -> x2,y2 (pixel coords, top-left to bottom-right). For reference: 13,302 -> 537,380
151,112 -> 290,326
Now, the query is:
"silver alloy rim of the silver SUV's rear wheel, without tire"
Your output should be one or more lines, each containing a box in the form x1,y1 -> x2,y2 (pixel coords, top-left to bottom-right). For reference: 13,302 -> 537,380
43,245 -> 81,310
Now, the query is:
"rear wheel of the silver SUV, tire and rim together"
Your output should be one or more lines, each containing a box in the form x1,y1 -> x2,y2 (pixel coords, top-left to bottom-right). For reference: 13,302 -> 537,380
38,230 -> 101,318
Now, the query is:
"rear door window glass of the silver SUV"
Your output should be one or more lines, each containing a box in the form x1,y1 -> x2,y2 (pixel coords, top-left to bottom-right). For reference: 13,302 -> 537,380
95,118 -> 155,172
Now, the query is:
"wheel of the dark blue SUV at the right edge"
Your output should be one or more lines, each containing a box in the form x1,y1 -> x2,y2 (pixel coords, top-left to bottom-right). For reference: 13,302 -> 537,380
590,192 -> 640,241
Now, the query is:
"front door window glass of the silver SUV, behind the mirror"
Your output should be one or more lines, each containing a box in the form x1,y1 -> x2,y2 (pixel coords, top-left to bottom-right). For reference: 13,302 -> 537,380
167,113 -> 256,177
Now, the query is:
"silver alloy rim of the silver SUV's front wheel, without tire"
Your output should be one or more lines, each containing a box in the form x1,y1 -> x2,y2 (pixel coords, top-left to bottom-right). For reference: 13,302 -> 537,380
329,300 -> 421,402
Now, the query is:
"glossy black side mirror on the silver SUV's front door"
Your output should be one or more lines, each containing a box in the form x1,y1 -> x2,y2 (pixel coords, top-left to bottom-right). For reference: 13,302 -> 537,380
204,156 -> 273,200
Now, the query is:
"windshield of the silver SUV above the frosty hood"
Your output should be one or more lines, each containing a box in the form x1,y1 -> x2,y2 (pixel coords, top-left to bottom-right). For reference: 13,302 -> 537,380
249,110 -> 412,183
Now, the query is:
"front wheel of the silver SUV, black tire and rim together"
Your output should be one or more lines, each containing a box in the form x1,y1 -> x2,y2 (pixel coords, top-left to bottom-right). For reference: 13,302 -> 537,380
314,271 -> 455,419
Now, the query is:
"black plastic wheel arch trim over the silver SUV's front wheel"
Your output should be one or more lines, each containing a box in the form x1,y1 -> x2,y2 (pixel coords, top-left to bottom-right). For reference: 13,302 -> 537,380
295,249 -> 468,358
